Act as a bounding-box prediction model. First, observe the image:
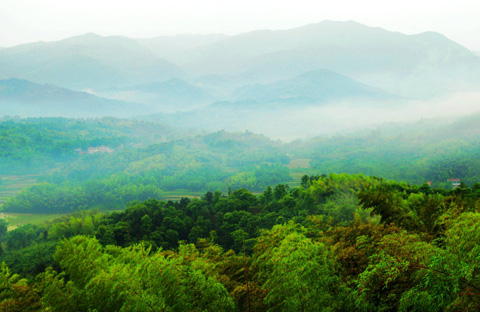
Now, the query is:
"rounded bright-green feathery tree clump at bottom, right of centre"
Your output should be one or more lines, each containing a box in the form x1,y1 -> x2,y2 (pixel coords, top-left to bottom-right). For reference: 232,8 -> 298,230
254,223 -> 342,311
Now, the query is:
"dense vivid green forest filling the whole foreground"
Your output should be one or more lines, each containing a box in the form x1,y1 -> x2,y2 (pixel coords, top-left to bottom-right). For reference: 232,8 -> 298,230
0,174 -> 480,311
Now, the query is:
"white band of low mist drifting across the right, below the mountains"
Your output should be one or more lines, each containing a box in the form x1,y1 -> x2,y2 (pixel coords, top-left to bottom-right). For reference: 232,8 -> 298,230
213,92 -> 480,142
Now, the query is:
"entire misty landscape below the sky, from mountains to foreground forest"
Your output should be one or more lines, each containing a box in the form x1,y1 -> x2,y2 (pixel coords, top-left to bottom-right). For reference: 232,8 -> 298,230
0,21 -> 480,312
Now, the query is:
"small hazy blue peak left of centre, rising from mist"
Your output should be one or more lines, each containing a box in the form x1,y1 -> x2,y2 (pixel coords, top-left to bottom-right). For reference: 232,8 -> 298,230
99,78 -> 215,112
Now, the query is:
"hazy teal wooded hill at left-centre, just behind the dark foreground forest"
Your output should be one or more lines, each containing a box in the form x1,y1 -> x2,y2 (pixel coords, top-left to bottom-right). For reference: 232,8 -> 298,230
3,131 -> 291,213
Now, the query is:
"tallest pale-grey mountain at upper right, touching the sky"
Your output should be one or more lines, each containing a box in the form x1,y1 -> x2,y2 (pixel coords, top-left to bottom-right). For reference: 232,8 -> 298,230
180,21 -> 480,97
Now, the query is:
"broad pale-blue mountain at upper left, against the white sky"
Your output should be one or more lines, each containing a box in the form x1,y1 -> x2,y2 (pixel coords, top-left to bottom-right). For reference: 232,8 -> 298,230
0,34 -> 184,90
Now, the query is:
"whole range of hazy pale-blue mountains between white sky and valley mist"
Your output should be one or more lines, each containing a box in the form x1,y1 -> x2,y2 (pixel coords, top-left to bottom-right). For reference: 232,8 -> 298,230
0,21 -> 480,119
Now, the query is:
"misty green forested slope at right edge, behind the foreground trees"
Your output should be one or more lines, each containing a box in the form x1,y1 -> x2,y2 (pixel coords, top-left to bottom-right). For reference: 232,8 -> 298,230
286,114 -> 480,187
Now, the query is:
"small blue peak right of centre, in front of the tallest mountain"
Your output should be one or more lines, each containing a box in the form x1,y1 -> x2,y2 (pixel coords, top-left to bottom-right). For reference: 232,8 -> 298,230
234,70 -> 394,104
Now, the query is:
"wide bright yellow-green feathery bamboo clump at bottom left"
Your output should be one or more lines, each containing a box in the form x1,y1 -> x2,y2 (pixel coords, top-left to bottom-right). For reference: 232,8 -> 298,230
50,236 -> 234,312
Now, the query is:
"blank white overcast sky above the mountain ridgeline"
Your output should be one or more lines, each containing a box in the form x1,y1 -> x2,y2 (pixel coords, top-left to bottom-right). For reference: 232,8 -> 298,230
0,0 -> 480,51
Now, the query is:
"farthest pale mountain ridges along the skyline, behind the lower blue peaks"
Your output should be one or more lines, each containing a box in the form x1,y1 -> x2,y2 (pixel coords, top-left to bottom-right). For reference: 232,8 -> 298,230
0,21 -> 480,100
